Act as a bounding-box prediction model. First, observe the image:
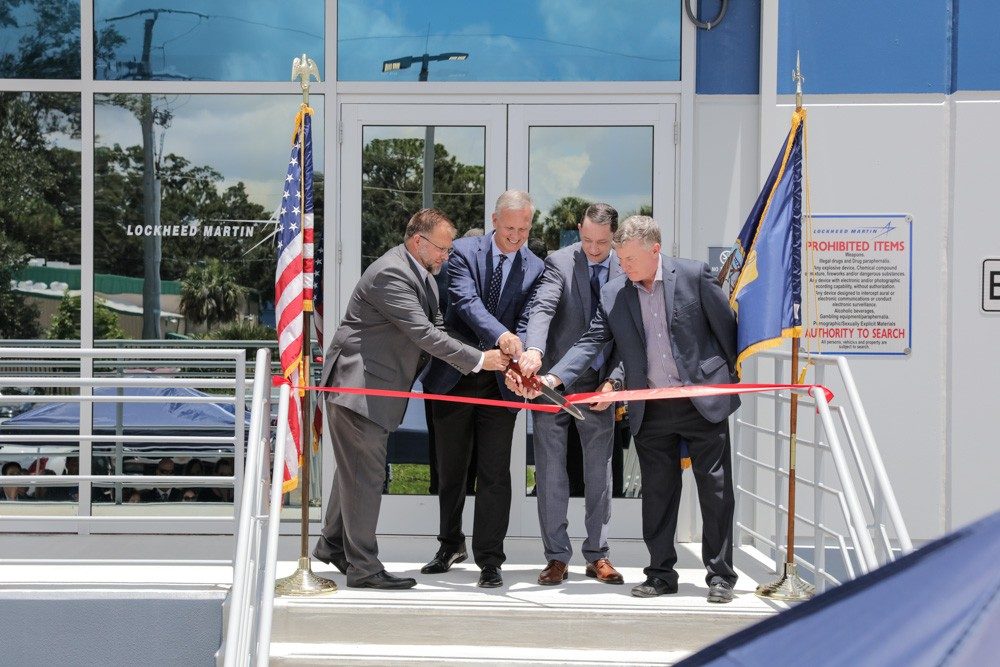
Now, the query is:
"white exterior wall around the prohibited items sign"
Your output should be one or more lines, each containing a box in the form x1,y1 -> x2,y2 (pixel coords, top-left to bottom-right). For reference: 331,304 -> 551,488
696,93 -> 1000,541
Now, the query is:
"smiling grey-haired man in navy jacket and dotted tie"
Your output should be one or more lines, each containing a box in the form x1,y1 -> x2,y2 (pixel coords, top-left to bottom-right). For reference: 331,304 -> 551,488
421,190 -> 544,588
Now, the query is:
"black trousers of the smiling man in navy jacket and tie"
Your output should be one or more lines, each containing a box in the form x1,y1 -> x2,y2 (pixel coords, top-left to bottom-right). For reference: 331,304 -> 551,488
431,371 -> 517,567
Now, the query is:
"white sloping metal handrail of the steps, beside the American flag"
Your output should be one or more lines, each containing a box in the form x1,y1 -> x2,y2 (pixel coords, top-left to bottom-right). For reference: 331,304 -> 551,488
219,349 -> 289,667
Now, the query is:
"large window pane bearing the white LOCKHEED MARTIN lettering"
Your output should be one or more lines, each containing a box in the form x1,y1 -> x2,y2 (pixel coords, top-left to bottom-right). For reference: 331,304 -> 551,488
94,94 -> 324,341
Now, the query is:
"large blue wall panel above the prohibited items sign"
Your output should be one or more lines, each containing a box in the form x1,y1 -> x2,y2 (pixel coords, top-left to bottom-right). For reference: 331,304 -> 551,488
772,0 -> 952,94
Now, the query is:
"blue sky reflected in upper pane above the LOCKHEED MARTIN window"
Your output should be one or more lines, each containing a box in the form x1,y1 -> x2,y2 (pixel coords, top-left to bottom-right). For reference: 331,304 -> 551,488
94,0 -> 326,81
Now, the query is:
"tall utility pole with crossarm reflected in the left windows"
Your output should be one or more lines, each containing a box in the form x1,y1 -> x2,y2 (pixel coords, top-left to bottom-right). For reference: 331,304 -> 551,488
108,9 -> 208,339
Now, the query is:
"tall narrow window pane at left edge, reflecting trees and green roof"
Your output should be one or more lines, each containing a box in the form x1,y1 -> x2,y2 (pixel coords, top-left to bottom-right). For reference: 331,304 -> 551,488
0,92 -> 80,340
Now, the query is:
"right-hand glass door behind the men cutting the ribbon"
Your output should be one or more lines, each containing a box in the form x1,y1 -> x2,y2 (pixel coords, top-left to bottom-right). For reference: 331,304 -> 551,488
507,104 -> 693,538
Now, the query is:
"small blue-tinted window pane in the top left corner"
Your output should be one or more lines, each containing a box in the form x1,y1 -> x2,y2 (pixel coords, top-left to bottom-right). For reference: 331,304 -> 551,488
0,0 -> 80,79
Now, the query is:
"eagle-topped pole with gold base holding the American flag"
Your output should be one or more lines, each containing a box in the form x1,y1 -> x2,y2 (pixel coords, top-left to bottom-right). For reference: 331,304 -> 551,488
274,53 -> 337,595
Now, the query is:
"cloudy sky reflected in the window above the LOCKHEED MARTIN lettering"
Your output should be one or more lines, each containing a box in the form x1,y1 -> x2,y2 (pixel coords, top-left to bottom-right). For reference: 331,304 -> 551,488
94,95 -> 324,211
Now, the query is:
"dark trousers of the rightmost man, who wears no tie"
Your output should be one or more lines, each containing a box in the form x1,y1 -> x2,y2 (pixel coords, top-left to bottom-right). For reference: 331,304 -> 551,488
635,398 -> 736,584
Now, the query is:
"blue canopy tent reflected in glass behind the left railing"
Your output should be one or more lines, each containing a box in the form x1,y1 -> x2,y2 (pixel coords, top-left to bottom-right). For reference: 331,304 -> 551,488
0,387 -> 249,436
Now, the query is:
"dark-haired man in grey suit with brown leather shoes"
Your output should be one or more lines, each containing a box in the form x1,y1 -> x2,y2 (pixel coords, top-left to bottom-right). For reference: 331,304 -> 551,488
518,204 -> 624,586
